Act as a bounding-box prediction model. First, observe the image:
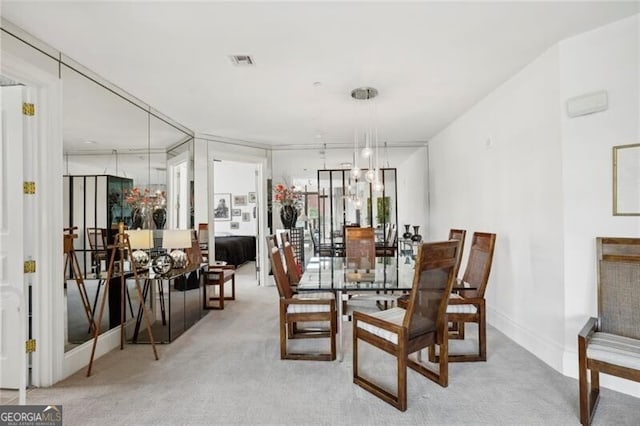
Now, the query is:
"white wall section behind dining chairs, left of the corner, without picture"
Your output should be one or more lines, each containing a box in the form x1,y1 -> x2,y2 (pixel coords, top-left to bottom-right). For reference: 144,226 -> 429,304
429,47 -> 564,369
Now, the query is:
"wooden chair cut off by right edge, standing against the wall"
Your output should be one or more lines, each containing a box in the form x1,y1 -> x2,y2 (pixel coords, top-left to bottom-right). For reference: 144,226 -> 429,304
578,237 -> 640,425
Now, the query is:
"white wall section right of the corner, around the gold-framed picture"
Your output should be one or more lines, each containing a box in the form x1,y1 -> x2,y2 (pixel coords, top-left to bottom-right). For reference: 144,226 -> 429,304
559,15 -> 640,396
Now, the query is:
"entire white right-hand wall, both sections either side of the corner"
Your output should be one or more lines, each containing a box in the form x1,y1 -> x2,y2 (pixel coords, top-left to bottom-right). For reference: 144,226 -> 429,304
429,16 -> 640,396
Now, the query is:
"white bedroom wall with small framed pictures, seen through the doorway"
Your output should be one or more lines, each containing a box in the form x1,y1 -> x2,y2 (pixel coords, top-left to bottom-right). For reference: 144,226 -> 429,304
213,161 -> 258,235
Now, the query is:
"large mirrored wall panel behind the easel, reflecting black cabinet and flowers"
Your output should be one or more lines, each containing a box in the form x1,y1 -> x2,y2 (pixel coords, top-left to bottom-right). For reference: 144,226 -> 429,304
60,59 -> 194,351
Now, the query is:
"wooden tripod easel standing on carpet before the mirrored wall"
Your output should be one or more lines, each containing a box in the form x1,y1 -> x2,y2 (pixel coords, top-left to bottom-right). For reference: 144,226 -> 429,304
87,222 -> 160,377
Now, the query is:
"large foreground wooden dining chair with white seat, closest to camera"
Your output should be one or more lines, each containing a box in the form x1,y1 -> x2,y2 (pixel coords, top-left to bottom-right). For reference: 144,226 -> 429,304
353,241 -> 459,411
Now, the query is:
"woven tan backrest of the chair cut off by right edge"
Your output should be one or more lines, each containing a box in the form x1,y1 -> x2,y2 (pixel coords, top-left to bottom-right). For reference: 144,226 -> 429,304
596,237 -> 640,339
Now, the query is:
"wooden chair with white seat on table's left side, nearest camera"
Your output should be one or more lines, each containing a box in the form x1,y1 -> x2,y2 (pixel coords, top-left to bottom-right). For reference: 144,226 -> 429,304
267,237 -> 338,361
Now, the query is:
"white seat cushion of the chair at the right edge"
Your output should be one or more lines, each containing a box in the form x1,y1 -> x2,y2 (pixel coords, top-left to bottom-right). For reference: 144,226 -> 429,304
587,332 -> 640,370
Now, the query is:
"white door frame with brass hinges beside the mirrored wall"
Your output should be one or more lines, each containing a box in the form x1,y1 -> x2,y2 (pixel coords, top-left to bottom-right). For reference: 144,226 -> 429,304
1,51 -> 64,386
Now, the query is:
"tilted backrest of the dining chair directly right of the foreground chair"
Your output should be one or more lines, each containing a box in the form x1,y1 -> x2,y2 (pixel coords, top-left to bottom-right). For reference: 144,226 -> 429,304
462,232 -> 496,297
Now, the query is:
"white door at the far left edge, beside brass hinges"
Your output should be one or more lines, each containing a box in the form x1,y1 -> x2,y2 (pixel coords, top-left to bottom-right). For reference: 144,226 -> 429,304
0,86 -> 26,389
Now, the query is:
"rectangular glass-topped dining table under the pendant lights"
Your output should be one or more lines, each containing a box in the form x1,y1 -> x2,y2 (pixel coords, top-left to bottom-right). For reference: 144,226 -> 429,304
297,256 -> 473,361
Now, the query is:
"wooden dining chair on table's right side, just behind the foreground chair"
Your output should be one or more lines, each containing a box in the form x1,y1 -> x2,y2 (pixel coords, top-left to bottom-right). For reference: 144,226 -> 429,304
447,232 -> 496,362
